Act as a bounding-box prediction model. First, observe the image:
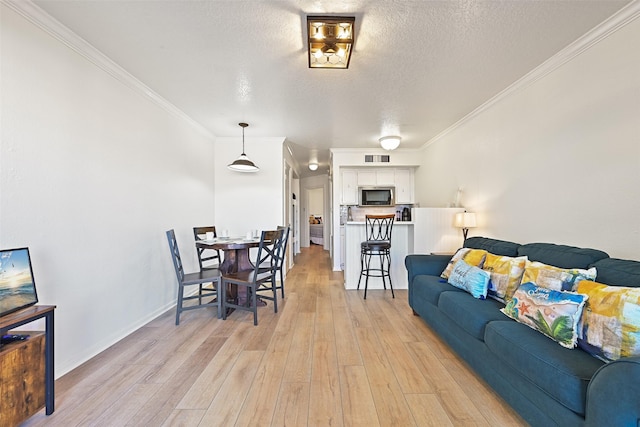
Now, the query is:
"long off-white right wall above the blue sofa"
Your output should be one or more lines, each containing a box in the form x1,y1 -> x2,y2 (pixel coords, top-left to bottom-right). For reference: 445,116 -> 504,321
416,14 -> 640,259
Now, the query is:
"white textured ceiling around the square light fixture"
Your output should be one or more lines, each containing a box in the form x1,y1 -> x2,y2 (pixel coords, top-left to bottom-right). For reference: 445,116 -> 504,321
34,0 -> 628,174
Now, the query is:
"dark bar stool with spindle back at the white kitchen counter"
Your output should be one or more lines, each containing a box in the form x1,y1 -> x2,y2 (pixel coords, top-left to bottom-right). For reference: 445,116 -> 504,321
358,214 -> 396,299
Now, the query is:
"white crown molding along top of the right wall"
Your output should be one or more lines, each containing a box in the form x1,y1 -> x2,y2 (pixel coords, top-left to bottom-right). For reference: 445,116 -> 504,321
421,0 -> 640,150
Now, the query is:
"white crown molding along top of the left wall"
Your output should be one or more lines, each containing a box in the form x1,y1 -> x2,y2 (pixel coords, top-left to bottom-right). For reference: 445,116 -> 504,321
1,0 -> 215,139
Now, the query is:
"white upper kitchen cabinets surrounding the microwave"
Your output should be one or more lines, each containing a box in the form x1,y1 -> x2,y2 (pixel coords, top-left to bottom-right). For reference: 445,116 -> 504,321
340,168 -> 415,205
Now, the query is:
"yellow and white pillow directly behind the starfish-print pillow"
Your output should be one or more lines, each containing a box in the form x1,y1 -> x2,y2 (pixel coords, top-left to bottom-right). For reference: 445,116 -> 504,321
522,261 -> 596,291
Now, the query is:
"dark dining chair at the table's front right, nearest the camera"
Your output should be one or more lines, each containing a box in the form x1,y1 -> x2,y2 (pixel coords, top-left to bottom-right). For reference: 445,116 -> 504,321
222,230 -> 283,325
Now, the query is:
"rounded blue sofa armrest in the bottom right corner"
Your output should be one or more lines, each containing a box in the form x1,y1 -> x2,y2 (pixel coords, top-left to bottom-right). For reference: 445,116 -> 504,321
585,357 -> 640,427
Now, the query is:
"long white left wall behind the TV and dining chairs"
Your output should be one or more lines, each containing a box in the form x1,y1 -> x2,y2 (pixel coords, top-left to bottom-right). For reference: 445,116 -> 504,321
0,5 -> 214,377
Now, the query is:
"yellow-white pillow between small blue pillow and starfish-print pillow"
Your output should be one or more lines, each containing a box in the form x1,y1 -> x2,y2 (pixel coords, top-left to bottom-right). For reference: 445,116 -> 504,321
482,253 -> 527,302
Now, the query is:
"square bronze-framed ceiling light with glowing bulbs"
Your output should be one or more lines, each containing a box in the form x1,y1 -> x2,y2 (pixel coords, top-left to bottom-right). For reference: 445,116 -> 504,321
307,16 -> 356,69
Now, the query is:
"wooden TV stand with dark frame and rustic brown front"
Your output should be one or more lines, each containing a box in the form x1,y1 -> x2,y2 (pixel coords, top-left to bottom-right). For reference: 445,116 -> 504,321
0,305 -> 56,426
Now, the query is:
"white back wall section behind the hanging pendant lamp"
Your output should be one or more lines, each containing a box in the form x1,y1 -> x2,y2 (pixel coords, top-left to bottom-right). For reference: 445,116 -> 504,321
212,137 -> 285,236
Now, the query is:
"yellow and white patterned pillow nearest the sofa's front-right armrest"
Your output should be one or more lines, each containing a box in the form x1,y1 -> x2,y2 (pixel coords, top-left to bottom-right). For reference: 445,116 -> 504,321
577,280 -> 640,361
